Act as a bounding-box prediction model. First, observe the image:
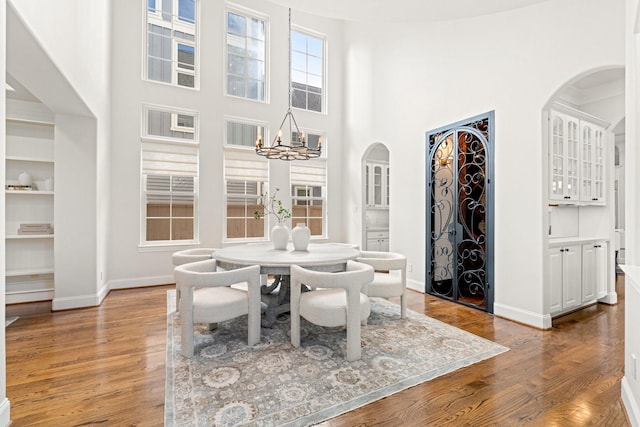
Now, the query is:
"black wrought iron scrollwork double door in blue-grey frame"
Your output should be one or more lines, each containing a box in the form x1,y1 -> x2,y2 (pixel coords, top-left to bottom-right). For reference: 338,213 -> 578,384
426,111 -> 494,313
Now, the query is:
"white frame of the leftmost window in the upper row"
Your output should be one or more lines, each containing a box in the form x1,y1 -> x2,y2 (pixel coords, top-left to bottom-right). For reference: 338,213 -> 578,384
142,0 -> 200,90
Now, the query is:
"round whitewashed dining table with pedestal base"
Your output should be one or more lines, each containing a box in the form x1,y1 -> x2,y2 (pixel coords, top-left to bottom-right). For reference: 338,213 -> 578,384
213,242 -> 360,327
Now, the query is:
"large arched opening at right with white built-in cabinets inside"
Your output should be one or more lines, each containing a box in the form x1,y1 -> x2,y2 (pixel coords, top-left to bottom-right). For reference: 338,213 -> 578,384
542,66 -> 625,310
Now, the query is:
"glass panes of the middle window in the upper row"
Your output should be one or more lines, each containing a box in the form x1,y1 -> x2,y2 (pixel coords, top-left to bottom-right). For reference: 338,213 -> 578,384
226,10 -> 266,101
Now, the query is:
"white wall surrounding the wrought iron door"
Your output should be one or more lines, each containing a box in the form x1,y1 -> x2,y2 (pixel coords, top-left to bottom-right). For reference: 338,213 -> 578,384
344,0 -> 624,326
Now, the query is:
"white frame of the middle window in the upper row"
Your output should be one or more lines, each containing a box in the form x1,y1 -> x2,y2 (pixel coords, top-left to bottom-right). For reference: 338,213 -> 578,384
222,3 -> 271,103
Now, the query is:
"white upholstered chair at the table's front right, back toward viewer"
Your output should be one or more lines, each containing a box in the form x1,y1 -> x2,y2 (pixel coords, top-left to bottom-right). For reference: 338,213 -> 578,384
290,261 -> 373,361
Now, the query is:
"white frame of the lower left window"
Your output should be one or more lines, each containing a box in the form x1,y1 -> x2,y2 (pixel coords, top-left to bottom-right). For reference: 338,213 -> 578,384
139,104 -> 200,249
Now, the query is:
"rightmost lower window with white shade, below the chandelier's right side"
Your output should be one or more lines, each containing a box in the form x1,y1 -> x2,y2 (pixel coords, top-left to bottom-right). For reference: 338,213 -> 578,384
291,158 -> 327,237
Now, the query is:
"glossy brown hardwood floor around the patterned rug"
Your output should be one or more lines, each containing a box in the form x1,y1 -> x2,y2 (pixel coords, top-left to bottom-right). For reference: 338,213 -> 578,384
6,276 -> 630,427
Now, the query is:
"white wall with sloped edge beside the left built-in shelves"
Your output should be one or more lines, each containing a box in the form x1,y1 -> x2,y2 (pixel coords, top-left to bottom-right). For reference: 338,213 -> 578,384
7,0 -> 111,309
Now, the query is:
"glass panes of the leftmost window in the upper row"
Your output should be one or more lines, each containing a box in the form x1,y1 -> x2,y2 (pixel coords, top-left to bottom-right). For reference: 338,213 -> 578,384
146,0 -> 199,88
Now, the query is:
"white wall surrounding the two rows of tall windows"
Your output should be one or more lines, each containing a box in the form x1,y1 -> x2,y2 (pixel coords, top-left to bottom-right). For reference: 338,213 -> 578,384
109,0 -> 344,288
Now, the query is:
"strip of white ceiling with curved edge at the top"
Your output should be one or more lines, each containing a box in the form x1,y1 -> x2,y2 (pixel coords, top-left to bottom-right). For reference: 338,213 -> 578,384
271,0 -> 549,23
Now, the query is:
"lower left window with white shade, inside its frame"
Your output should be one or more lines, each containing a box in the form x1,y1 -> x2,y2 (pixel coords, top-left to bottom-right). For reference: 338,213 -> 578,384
140,106 -> 198,246
